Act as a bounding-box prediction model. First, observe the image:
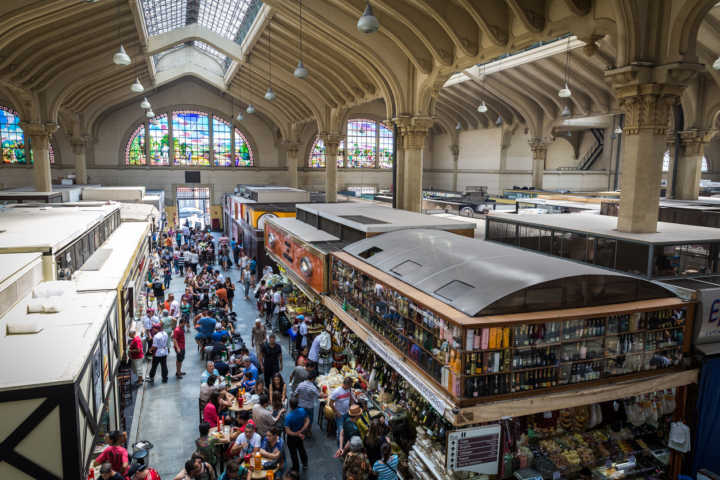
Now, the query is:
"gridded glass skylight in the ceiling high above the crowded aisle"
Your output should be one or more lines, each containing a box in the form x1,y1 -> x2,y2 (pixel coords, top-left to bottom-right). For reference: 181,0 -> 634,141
142,0 -> 262,69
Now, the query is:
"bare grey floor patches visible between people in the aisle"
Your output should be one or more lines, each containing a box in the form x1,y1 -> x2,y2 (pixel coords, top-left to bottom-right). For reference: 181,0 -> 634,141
137,258 -> 342,480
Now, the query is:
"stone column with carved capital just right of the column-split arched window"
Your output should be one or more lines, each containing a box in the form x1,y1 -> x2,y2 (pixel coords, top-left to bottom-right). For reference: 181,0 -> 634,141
396,117 -> 433,212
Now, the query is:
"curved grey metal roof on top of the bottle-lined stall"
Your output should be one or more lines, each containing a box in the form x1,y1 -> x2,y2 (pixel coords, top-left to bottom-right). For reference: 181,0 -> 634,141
344,229 -> 675,316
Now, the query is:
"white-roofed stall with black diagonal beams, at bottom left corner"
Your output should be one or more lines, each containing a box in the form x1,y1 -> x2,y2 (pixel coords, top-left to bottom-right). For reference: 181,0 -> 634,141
0,282 -> 120,480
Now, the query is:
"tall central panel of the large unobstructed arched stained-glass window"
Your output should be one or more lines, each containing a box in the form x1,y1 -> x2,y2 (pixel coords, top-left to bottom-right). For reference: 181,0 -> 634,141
173,110 -> 210,166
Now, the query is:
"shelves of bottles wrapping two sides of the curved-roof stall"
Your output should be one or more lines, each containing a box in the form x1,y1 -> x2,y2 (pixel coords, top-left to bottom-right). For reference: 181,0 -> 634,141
331,258 -> 688,399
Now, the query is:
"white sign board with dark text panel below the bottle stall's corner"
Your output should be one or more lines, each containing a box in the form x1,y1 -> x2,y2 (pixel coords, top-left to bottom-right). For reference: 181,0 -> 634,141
447,424 -> 500,475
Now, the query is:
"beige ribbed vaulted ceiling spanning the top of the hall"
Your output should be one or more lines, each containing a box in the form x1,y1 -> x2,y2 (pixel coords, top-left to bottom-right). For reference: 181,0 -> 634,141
0,0 -> 720,142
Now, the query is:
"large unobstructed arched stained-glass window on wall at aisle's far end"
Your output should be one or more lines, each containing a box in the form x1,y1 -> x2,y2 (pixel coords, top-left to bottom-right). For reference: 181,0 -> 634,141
123,110 -> 254,167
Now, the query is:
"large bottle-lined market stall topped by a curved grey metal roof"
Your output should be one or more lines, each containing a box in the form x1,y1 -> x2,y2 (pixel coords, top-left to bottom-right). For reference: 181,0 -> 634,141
323,230 -> 697,479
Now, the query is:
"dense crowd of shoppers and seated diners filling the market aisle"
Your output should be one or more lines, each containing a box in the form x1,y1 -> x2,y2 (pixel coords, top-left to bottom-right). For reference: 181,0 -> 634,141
95,225 -> 398,480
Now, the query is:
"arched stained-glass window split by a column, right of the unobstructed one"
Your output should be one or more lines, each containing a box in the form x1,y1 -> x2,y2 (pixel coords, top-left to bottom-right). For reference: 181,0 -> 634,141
308,119 -> 393,168
